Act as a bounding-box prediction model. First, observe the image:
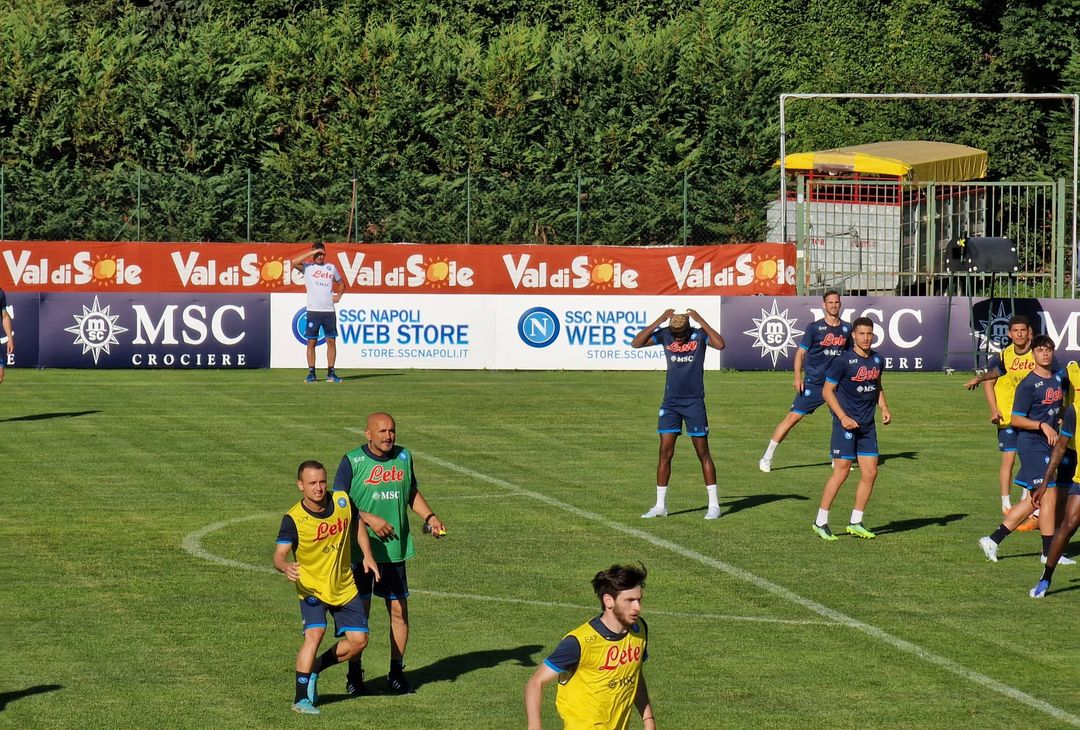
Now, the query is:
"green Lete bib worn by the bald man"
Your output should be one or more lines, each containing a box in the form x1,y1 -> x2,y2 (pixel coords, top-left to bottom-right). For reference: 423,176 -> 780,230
346,446 -> 415,563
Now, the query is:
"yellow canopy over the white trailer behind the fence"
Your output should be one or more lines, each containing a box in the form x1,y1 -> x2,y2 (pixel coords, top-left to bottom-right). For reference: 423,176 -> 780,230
777,141 -> 986,183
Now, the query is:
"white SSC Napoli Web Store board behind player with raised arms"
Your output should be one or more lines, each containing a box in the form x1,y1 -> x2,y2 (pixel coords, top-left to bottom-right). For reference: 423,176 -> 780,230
492,296 -> 723,370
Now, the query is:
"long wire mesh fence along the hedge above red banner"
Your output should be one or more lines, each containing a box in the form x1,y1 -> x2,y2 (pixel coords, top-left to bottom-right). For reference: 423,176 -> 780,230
0,165 -> 725,245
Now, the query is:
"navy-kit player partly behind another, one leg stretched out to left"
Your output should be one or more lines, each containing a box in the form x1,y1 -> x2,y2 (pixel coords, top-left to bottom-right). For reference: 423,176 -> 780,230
757,292 -> 851,474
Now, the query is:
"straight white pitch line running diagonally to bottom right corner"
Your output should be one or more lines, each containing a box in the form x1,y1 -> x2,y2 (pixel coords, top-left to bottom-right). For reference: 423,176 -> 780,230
413,449 -> 1080,727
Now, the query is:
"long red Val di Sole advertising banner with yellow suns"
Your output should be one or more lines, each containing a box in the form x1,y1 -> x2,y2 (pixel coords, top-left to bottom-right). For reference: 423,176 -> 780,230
0,241 -> 795,296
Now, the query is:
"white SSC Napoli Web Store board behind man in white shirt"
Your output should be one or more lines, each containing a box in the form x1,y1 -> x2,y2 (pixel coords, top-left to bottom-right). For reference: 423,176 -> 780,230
270,294 -> 496,369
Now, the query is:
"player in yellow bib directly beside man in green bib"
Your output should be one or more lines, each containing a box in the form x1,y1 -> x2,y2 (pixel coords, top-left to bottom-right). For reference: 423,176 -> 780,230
273,461 -> 379,715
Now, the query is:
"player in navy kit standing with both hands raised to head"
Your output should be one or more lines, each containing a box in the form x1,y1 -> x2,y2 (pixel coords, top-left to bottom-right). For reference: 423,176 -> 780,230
630,309 -> 724,519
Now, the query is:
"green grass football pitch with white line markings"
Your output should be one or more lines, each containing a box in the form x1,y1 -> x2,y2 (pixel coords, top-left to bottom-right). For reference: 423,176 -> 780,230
0,370 -> 1080,730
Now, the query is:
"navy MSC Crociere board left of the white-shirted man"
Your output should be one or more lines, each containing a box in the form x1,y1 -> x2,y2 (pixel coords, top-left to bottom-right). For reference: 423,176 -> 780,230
39,293 -> 270,368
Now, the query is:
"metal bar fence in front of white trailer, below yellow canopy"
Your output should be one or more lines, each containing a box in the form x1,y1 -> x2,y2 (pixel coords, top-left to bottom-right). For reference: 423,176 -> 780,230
768,176 -> 1072,297
